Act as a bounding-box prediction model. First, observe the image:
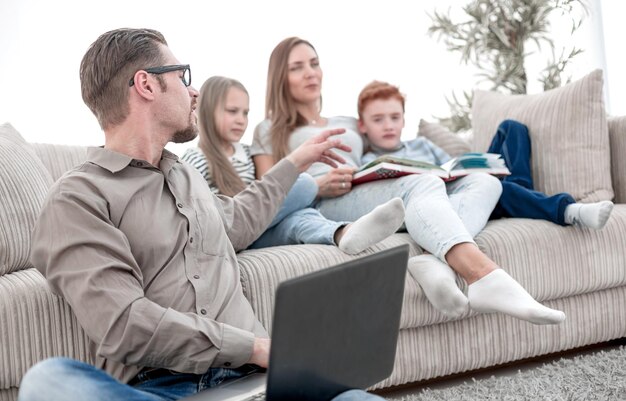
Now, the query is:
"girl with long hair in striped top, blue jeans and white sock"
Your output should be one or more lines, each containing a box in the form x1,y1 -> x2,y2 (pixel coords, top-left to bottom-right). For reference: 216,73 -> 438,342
181,77 -> 404,254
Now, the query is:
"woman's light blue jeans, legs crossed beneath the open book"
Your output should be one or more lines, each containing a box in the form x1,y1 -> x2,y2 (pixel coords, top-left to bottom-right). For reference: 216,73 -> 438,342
317,173 -> 502,262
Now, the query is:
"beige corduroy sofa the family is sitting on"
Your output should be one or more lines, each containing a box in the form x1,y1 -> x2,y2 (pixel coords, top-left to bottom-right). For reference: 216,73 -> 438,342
0,76 -> 626,401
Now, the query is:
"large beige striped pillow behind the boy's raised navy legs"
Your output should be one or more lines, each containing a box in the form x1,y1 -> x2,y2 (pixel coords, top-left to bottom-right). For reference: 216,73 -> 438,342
472,70 -> 613,202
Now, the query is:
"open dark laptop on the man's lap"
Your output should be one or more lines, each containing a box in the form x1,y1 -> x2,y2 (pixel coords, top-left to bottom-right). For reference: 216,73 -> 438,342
184,245 -> 409,401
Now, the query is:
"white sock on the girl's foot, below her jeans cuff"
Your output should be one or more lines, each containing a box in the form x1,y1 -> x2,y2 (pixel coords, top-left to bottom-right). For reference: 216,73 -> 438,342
338,198 -> 404,255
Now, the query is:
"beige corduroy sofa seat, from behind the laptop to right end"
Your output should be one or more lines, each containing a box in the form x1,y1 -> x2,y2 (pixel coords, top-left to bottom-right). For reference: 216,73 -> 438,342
237,205 -> 626,330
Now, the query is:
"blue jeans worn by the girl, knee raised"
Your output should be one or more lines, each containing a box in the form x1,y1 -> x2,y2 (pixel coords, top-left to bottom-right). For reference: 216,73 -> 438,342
249,173 -> 348,249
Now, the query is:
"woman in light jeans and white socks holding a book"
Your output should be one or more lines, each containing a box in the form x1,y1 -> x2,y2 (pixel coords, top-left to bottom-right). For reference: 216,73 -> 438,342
251,37 -> 565,324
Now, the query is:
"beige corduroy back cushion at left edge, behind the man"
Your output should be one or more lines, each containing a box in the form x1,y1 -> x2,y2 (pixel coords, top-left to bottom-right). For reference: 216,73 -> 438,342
0,123 -> 52,276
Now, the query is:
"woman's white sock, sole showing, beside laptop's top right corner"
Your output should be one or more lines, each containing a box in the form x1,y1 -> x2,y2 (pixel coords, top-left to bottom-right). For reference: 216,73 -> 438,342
408,254 -> 468,318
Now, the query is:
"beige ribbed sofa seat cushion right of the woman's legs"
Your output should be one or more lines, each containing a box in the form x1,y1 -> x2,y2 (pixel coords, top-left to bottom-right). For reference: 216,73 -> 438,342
476,205 -> 626,301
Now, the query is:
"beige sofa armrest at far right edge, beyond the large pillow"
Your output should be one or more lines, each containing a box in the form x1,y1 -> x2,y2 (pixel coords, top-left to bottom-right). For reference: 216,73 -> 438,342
608,116 -> 626,203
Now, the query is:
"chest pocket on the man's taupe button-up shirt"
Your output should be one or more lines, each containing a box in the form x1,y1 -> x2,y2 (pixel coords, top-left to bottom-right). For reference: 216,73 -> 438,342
193,198 -> 230,256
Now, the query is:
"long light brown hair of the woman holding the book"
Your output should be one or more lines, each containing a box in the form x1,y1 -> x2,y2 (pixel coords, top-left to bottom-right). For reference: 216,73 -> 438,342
265,37 -> 317,161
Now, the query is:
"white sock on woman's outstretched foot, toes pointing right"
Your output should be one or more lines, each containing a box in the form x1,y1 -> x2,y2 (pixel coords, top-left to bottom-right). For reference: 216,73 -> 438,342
467,269 -> 565,324
